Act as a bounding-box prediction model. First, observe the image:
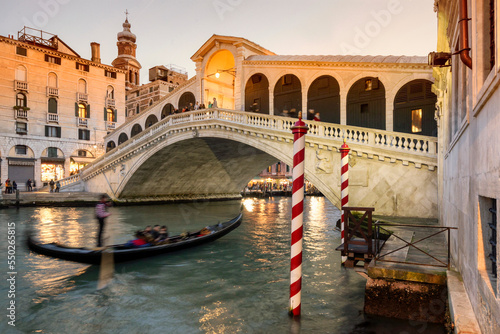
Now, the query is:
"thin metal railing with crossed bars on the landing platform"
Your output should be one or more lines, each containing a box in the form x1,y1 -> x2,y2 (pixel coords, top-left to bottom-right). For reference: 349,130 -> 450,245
373,222 -> 457,269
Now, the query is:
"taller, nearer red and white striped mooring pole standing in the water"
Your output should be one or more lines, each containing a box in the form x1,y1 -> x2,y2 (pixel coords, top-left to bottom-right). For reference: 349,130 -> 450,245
290,112 -> 309,316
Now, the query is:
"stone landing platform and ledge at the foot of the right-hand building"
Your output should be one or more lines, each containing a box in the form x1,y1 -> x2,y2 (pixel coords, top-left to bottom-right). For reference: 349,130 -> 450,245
364,217 -> 481,333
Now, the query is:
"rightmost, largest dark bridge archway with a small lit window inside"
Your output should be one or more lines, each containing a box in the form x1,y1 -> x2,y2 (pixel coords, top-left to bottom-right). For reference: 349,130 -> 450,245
394,79 -> 437,136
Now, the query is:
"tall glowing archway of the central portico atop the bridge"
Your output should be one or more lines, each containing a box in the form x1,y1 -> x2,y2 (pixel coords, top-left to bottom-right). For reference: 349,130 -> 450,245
203,49 -> 236,109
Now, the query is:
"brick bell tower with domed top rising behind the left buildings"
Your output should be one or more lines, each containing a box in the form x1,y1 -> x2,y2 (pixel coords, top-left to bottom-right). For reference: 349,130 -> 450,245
111,11 -> 142,90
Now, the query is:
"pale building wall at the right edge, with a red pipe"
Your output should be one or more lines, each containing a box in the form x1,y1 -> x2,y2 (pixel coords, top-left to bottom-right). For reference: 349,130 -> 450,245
434,0 -> 500,333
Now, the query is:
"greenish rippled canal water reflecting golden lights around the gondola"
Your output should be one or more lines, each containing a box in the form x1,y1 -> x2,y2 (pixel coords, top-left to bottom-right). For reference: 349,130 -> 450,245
0,197 -> 444,334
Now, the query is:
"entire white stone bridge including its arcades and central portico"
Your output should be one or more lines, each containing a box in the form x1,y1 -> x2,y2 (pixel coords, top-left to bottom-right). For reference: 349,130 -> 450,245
59,35 -> 437,217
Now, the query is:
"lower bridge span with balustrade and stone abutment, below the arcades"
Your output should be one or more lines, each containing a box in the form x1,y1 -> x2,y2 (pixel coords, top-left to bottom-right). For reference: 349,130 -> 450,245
63,109 -> 437,217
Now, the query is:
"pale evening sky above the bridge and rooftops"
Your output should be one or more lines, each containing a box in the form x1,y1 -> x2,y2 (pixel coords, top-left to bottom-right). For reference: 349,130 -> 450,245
0,0 -> 437,84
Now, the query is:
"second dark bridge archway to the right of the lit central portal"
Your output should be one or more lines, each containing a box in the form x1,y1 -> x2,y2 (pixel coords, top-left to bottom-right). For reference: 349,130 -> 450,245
274,74 -> 302,117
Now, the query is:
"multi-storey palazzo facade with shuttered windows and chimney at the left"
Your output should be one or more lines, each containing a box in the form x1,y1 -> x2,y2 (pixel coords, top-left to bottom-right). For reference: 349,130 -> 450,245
0,27 -> 125,190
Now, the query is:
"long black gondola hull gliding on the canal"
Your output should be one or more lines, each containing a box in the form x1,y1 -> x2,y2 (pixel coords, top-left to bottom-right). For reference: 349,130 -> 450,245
27,213 -> 242,264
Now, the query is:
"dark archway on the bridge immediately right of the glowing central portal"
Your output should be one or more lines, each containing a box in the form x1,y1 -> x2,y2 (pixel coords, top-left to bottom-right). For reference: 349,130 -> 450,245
245,73 -> 269,114
